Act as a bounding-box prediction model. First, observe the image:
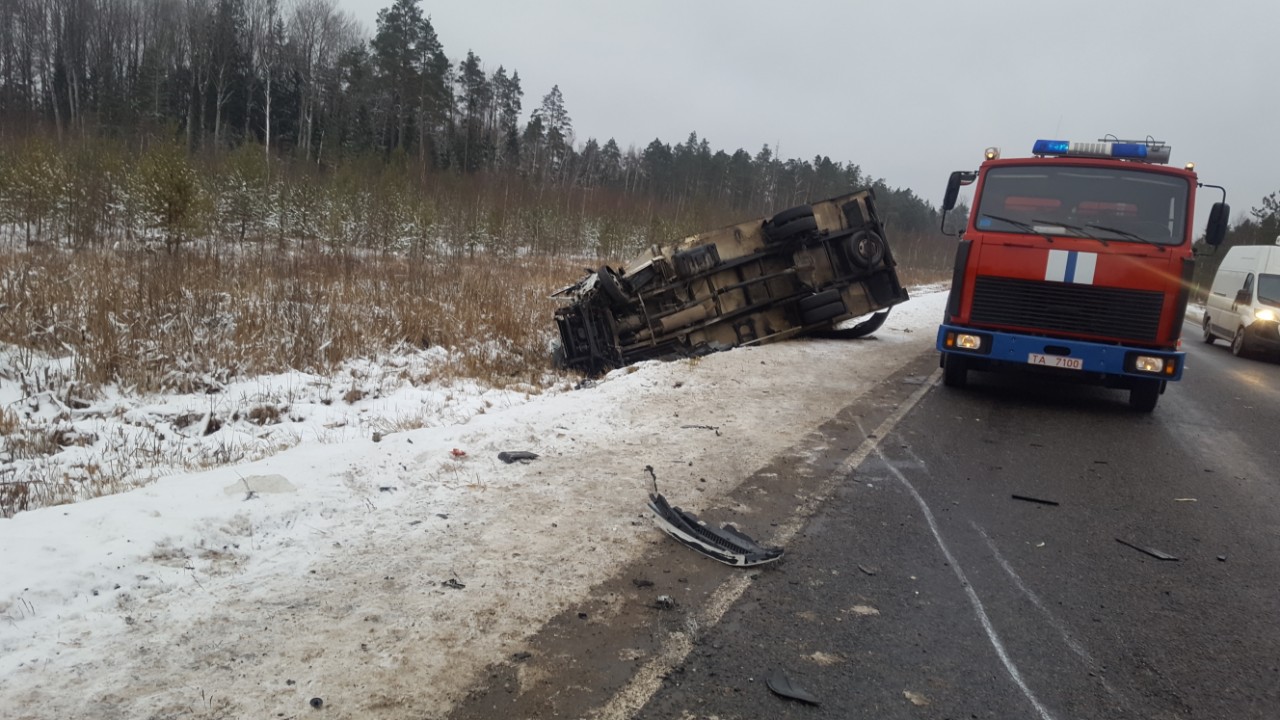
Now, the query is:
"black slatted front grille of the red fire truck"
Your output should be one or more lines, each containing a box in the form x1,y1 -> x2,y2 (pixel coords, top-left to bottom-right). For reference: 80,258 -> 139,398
969,277 -> 1165,342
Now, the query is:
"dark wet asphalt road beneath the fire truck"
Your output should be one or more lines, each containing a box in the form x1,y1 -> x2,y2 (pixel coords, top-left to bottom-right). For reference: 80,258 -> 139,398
454,327 -> 1280,720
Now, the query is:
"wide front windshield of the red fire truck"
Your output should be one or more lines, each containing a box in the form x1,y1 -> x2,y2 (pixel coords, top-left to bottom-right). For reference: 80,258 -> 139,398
975,165 -> 1192,245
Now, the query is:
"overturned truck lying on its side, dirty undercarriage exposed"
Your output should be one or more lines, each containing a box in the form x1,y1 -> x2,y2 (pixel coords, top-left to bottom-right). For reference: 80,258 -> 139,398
554,190 -> 908,375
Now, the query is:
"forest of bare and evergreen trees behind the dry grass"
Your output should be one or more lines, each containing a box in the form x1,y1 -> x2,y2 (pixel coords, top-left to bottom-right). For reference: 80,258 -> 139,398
0,0 -> 947,263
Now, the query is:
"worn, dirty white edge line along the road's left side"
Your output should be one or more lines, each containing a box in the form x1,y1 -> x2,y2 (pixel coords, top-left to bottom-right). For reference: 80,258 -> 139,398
590,369 -> 942,720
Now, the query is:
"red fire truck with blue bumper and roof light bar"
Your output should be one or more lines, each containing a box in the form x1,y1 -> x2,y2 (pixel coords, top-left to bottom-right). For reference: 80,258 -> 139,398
937,138 -> 1230,413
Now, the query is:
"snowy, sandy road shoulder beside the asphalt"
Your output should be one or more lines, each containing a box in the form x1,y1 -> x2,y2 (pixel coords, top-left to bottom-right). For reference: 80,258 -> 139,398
0,288 -> 946,719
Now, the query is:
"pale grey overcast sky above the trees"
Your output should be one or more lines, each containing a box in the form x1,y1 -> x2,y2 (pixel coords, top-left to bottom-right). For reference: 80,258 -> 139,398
338,0 -> 1280,224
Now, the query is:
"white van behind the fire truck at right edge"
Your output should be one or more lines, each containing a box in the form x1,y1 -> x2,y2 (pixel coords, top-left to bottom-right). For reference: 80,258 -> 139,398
1204,237 -> 1280,355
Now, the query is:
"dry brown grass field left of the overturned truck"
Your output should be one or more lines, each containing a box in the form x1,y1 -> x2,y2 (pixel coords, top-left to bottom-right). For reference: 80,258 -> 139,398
0,244 -> 581,392
